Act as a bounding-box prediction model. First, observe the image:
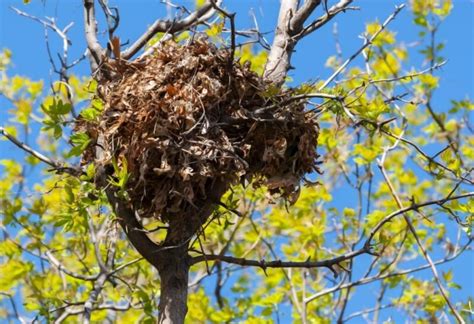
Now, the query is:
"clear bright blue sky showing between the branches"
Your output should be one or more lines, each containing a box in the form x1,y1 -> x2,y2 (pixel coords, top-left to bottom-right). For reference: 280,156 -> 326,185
0,0 -> 474,320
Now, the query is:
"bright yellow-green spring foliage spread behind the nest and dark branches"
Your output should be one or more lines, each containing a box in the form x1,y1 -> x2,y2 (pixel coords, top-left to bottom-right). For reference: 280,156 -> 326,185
0,0 -> 474,323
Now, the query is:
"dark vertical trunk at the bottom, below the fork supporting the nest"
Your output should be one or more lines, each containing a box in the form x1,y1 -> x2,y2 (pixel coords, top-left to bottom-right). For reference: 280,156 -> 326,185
158,246 -> 189,324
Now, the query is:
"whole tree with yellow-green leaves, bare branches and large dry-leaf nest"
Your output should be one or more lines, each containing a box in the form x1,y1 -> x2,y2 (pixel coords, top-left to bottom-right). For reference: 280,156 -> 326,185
0,0 -> 474,323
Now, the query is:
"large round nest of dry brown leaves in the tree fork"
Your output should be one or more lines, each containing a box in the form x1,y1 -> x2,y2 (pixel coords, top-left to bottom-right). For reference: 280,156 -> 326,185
77,39 -> 319,221
